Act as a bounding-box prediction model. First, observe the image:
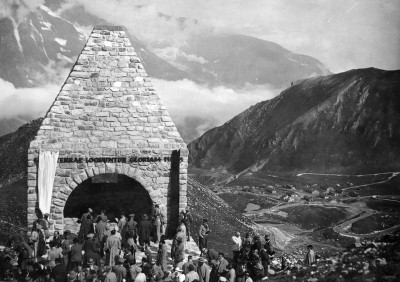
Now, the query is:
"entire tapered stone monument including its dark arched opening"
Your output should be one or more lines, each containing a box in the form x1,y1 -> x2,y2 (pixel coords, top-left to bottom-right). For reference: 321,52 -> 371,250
27,26 -> 188,236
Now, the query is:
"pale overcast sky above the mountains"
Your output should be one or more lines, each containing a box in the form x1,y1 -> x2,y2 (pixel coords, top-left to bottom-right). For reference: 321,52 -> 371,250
73,0 -> 400,72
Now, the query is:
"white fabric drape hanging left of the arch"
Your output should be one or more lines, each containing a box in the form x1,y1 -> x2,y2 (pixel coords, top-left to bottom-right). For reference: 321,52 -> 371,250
38,151 -> 58,214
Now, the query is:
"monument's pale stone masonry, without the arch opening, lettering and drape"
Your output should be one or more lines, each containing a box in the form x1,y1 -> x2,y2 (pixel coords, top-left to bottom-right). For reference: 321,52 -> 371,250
28,26 -> 188,232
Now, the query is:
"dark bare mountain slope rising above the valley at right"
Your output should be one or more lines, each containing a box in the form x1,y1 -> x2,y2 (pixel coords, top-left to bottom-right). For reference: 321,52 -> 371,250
189,68 -> 400,174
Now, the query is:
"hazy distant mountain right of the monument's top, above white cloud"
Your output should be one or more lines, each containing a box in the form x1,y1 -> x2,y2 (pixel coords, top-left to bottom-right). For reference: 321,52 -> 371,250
155,34 -> 330,88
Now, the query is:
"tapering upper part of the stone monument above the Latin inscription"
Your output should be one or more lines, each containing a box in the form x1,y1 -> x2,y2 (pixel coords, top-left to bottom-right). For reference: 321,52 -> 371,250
32,26 -> 185,149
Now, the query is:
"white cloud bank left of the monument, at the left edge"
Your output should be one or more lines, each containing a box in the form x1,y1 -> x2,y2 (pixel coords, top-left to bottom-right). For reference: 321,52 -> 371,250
0,78 -> 60,119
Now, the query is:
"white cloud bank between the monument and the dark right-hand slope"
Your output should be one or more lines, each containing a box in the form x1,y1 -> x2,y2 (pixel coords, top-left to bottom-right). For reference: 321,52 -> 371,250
152,79 -> 280,142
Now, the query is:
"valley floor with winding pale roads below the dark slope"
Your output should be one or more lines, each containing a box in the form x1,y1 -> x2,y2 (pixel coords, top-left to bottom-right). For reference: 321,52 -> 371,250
192,170 -> 400,253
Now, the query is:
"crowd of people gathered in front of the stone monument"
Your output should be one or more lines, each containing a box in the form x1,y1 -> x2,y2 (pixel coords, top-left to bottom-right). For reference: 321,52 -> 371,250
0,206 -> 313,282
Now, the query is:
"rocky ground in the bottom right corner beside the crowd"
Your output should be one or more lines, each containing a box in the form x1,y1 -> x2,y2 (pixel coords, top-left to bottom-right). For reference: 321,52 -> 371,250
269,231 -> 400,281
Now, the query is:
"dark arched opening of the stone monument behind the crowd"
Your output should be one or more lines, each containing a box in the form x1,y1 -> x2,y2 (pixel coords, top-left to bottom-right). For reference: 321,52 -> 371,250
64,173 -> 153,225
